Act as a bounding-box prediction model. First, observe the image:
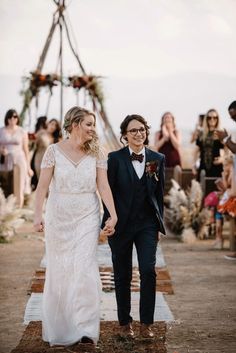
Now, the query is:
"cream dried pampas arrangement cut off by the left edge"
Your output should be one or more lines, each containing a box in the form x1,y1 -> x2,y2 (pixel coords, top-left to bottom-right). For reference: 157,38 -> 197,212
0,188 -> 24,243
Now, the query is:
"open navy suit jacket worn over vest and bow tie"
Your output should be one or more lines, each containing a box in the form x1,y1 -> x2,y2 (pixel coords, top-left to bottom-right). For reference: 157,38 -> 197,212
102,147 -> 165,234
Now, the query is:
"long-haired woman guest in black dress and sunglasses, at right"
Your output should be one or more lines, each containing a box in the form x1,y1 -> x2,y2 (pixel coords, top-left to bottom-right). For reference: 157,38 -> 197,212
193,109 -> 224,180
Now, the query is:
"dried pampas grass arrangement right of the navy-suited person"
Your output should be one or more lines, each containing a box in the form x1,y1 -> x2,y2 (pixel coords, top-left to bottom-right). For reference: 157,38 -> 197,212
165,179 -> 209,242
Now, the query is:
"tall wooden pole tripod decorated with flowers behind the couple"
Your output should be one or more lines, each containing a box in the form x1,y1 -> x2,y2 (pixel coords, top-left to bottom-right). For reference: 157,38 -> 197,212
20,0 -> 120,149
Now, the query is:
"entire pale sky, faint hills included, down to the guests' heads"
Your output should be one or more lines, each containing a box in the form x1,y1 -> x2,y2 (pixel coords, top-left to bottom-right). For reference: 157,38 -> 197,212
0,0 -> 236,136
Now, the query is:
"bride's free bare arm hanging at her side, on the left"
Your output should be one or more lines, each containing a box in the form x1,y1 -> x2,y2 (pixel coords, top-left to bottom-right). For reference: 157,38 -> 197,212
34,167 -> 54,232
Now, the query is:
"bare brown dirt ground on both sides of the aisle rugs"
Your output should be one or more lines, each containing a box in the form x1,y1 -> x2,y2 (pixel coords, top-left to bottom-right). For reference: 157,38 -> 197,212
0,223 -> 236,353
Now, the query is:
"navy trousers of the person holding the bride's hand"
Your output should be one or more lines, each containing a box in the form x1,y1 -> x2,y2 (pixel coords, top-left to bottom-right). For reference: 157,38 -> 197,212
109,219 -> 158,325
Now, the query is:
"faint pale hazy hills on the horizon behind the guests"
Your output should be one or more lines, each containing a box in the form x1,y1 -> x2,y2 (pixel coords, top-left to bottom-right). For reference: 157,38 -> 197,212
0,73 -> 236,133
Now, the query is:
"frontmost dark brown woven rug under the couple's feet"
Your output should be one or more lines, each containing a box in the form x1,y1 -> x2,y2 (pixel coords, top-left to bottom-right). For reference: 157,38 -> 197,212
11,321 -> 167,353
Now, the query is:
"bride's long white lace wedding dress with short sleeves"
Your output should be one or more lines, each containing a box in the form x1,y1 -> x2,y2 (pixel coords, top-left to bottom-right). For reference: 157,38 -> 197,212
41,144 -> 107,346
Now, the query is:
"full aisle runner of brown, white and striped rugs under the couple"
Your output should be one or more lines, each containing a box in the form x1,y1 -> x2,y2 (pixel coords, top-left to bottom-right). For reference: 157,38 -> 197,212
12,245 -> 174,353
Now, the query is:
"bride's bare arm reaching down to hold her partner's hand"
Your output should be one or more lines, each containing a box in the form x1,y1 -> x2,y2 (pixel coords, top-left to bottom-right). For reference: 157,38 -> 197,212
97,168 -> 117,235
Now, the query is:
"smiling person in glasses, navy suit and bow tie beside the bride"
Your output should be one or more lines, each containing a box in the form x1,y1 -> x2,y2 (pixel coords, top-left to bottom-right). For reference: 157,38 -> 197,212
103,115 -> 165,338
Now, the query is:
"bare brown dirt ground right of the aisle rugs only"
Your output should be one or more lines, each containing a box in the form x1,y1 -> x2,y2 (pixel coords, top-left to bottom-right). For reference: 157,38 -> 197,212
162,239 -> 236,353
